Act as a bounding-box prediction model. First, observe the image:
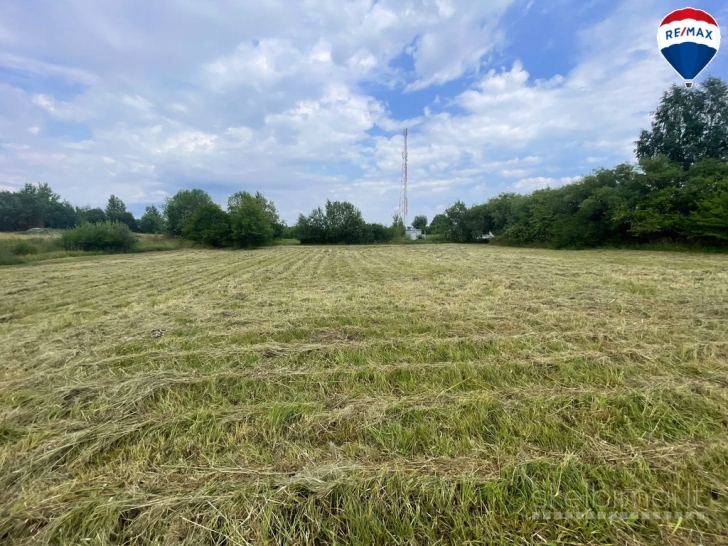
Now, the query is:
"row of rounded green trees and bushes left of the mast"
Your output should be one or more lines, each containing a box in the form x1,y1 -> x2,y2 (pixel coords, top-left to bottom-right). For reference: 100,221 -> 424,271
0,177 -> 404,248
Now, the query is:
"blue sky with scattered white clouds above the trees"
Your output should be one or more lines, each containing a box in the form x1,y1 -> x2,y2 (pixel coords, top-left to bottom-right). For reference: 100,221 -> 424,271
0,0 -> 728,225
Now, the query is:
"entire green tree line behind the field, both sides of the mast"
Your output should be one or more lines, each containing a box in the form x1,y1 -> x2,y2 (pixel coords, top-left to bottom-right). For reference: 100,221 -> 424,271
0,78 -> 728,248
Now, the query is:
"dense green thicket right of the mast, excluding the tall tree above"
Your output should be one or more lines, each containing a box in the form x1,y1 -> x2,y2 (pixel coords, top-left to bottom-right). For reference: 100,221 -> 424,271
430,156 -> 728,248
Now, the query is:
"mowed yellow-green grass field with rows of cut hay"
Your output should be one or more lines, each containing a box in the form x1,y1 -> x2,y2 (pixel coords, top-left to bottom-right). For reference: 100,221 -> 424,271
0,245 -> 728,545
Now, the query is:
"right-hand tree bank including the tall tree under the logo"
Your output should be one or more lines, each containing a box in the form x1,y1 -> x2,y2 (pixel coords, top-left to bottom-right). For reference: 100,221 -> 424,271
429,78 -> 728,248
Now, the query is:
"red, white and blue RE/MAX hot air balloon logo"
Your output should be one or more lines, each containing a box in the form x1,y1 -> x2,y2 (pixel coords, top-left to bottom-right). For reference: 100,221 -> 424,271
657,8 -> 720,87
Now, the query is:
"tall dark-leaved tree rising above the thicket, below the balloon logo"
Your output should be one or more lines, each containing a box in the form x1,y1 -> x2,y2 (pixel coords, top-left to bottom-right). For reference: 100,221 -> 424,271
635,77 -> 728,169
